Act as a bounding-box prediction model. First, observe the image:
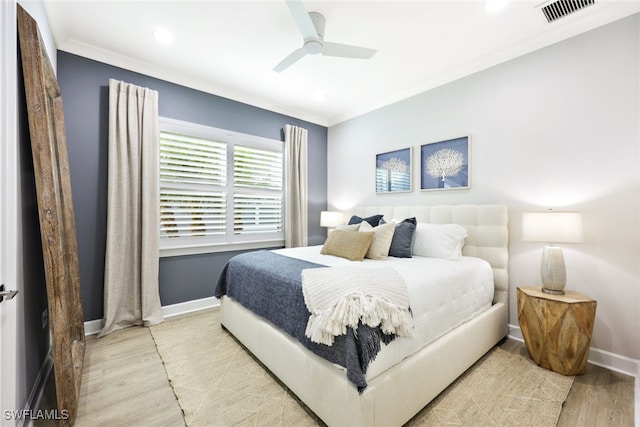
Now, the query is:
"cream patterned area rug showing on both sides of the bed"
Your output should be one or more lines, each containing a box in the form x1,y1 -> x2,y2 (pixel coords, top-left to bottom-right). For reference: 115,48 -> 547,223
151,309 -> 573,427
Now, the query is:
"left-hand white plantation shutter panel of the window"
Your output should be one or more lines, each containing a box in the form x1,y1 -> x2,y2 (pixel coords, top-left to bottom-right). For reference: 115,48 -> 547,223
160,132 -> 227,239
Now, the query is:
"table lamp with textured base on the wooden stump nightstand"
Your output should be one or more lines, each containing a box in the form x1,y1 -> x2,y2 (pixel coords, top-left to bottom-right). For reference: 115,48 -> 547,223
522,211 -> 582,295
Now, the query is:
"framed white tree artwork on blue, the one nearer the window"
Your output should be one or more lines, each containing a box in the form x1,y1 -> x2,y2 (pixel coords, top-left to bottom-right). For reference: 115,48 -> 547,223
376,147 -> 412,193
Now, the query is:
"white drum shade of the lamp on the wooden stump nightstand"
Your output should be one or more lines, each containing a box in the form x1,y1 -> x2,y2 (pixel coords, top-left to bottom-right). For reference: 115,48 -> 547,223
522,212 -> 582,243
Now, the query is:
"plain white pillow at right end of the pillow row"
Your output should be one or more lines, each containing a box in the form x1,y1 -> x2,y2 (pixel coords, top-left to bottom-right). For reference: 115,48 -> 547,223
413,222 -> 467,260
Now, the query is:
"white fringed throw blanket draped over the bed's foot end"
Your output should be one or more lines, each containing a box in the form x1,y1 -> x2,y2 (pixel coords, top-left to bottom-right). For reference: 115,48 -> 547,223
302,267 -> 413,345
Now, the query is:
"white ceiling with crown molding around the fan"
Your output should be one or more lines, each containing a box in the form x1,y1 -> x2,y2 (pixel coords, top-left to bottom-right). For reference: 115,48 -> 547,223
45,0 -> 640,126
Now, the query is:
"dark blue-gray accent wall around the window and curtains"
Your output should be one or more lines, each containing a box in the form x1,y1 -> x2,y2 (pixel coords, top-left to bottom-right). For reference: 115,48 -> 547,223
57,51 -> 327,321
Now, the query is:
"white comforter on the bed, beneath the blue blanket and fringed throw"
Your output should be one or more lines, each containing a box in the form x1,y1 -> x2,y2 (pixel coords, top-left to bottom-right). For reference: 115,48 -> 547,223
274,246 -> 494,379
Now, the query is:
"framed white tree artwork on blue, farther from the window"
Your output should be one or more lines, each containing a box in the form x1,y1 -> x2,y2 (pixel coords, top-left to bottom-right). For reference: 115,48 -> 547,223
420,136 -> 470,190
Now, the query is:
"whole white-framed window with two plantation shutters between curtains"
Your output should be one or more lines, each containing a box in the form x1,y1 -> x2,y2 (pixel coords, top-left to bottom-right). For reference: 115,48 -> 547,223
160,118 -> 284,256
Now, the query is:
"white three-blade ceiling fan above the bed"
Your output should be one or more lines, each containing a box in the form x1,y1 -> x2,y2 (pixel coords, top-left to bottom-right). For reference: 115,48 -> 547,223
273,0 -> 376,73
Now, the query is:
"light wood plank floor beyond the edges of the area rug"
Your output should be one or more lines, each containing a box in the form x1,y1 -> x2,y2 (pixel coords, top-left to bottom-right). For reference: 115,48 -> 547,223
34,310 -> 634,427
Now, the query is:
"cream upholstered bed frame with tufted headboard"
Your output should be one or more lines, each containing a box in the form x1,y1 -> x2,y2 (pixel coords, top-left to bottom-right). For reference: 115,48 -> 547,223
221,205 -> 509,427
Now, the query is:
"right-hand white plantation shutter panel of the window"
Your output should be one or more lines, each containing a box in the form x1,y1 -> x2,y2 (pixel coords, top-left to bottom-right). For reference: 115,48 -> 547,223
233,144 -> 283,235
